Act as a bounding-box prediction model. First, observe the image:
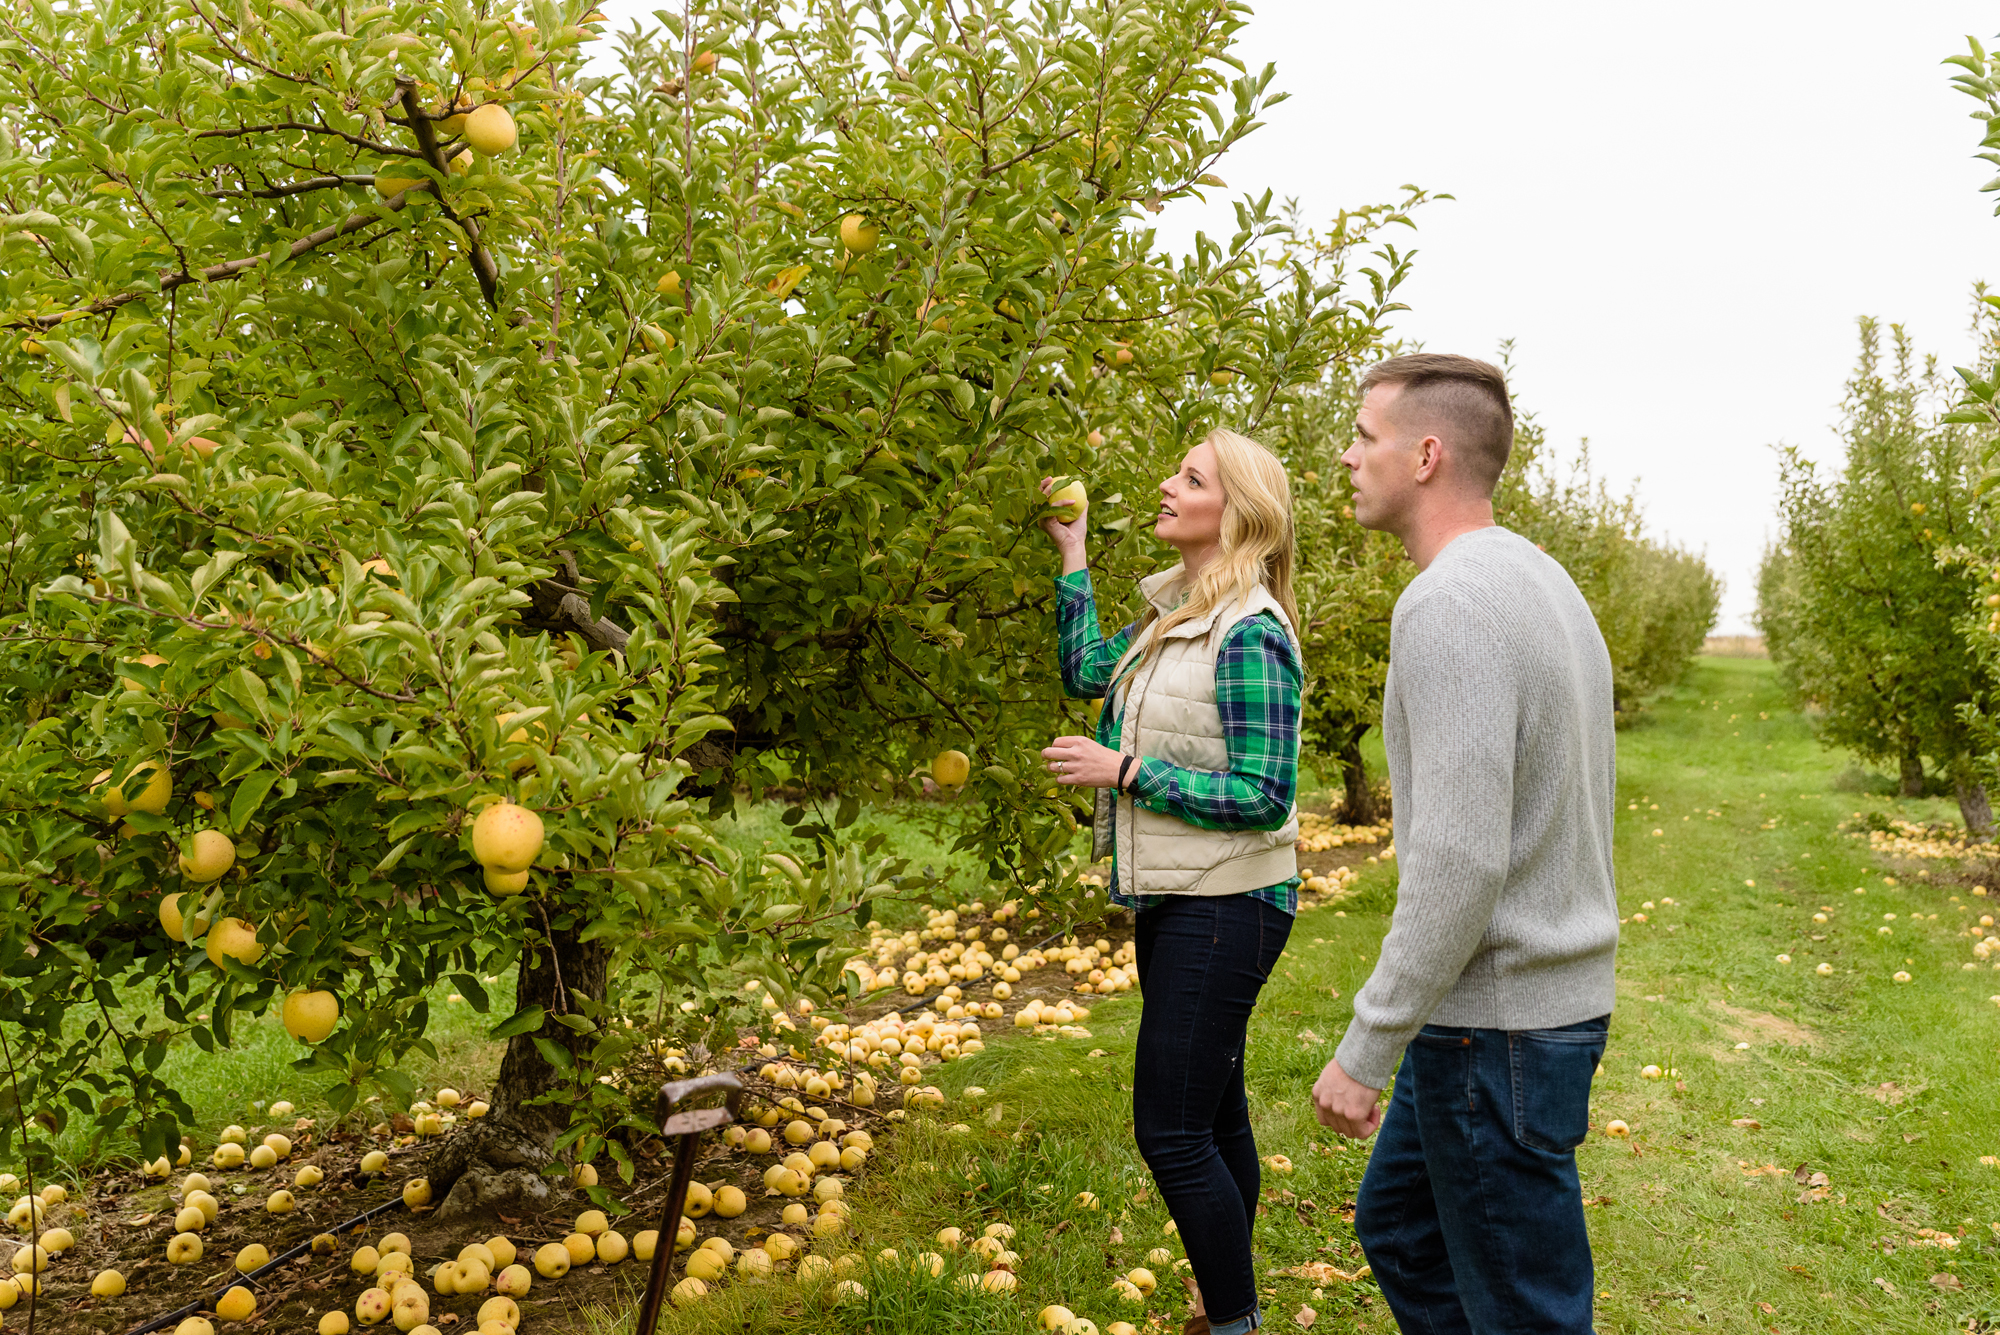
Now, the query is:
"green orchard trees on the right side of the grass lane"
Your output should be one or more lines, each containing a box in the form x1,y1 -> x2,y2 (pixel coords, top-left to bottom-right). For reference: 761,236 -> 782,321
1758,40 -> 2000,839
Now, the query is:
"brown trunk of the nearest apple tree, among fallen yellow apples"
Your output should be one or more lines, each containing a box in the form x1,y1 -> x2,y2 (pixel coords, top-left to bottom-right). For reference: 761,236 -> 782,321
430,911 -> 610,1219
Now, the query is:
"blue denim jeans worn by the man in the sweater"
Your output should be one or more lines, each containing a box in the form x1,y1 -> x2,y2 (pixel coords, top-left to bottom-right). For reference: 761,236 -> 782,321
1354,1015 -> 1610,1335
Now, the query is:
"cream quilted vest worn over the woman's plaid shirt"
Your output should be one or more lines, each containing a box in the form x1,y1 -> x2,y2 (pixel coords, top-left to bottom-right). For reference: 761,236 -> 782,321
1116,566 -> 1298,895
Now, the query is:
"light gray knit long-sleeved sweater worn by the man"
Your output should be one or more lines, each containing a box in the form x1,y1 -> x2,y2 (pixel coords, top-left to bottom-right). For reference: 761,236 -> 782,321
1336,528 -> 1618,1089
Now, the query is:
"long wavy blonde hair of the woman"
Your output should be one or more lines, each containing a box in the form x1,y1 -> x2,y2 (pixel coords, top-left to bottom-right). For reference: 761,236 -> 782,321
1132,426 -> 1298,669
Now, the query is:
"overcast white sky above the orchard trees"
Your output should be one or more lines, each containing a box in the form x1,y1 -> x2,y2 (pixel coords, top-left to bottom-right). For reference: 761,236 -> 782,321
588,0 -> 2000,634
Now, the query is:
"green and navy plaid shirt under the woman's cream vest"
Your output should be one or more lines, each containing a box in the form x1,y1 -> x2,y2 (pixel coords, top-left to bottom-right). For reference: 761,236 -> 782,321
1056,570 -> 1304,913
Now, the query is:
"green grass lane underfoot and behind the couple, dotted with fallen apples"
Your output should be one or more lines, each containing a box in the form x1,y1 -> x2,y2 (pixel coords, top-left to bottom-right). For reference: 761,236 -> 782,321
608,660 -> 2000,1335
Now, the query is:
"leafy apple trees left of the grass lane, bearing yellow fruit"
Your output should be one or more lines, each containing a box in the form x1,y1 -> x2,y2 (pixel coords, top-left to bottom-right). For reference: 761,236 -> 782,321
0,0 -> 1712,1209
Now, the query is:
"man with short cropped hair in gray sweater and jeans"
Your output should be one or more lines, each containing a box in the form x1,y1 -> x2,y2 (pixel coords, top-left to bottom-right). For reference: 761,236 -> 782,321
1312,354 -> 1618,1335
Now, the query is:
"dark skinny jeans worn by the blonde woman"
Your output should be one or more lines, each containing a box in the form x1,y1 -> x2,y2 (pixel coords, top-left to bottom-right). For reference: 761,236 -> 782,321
1132,895 -> 1292,1335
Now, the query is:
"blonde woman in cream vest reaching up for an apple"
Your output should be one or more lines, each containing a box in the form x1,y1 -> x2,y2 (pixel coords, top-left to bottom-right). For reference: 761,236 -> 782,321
1042,430 -> 1302,1335
